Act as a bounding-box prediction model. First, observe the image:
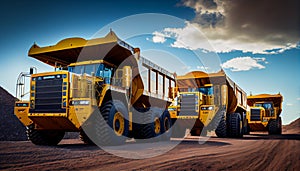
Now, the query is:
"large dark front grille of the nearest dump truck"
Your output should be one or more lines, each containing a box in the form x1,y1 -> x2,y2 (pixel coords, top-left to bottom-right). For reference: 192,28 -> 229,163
30,76 -> 66,113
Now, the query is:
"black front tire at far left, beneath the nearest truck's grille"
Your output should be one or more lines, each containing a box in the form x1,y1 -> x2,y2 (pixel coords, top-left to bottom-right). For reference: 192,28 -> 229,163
26,124 -> 65,146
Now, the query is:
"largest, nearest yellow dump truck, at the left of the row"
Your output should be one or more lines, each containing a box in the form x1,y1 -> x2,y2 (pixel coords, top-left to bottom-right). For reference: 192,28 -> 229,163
15,31 -> 175,145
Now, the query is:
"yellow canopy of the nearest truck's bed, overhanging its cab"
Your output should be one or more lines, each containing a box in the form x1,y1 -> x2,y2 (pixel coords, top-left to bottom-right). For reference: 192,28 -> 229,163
28,31 -> 134,67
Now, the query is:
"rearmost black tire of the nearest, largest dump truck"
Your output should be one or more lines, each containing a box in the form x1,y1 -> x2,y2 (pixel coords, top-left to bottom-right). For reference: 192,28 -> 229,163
160,110 -> 172,141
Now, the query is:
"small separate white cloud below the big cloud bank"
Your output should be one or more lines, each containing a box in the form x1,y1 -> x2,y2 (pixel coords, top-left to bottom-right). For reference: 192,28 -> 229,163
222,56 -> 266,71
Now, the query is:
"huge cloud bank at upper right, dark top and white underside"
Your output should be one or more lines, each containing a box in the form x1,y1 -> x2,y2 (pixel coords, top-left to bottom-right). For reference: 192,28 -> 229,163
153,0 -> 300,54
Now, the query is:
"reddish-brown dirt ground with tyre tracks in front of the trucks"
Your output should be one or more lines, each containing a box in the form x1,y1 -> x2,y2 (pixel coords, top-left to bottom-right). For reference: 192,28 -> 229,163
0,132 -> 300,170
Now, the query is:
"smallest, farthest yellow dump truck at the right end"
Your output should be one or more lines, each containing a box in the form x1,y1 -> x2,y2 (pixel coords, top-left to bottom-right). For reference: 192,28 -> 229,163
247,94 -> 283,134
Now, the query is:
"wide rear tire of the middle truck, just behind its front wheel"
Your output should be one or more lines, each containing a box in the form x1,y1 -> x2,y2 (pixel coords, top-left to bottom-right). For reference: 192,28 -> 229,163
227,113 -> 243,138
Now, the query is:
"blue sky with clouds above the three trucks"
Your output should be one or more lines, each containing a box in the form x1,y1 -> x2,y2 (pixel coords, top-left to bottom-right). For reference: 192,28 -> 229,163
0,0 -> 300,124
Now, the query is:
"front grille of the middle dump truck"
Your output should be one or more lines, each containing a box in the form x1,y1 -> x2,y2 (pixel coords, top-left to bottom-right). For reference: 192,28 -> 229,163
179,94 -> 198,116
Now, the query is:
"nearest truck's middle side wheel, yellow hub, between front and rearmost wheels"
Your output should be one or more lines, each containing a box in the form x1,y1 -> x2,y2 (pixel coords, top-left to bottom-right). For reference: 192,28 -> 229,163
134,109 -> 161,142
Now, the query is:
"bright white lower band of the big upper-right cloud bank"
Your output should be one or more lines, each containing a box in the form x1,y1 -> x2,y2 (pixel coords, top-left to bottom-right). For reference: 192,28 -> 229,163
152,21 -> 297,54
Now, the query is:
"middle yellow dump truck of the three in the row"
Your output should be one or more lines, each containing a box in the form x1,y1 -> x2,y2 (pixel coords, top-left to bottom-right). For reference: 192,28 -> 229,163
168,70 -> 247,138
